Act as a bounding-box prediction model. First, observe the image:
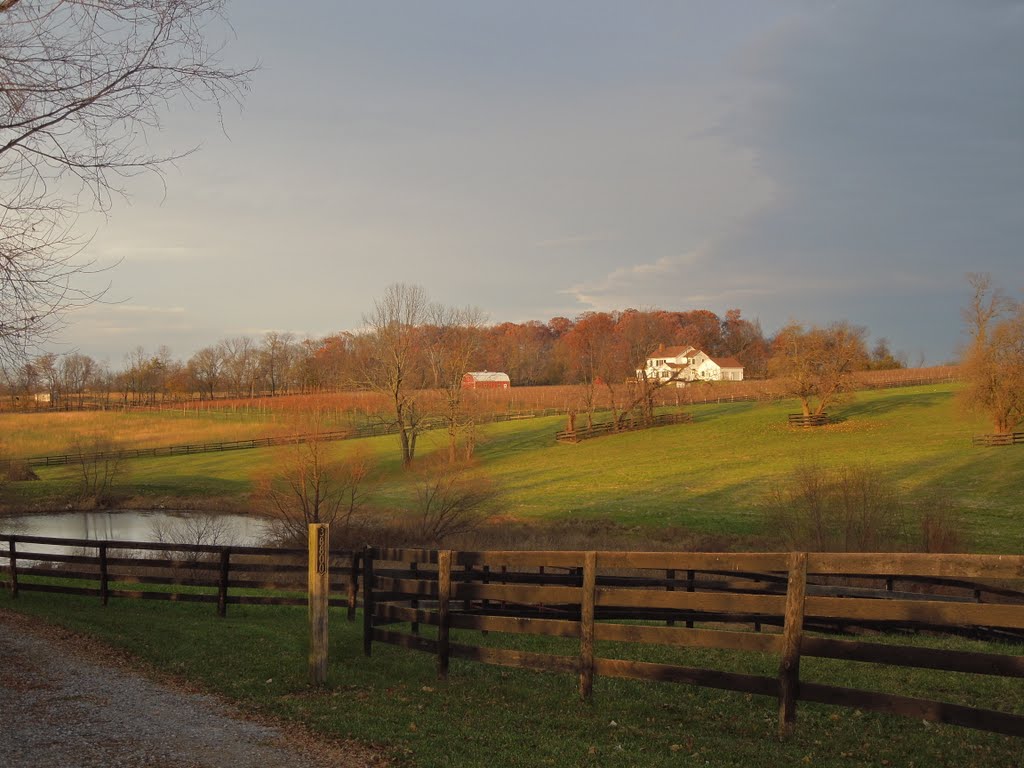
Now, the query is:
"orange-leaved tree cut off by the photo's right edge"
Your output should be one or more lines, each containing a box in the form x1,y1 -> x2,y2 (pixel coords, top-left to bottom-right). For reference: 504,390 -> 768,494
963,274 -> 1024,434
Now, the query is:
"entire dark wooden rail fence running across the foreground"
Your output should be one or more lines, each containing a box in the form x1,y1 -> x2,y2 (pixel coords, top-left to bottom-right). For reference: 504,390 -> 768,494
0,536 -> 1024,736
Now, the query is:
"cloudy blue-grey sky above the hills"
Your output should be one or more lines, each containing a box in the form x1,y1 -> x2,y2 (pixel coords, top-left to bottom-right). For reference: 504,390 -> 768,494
58,0 -> 1024,366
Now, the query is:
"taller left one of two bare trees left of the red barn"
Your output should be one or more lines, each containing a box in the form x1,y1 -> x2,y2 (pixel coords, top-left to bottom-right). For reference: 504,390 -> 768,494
357,283 -> 428,468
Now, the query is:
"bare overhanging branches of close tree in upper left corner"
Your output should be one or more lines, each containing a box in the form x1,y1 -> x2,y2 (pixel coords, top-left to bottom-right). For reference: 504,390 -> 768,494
0,0 -> 252,359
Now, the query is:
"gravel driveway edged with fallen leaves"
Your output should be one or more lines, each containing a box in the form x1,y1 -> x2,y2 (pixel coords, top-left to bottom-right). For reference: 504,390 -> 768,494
0,610 -> 386,768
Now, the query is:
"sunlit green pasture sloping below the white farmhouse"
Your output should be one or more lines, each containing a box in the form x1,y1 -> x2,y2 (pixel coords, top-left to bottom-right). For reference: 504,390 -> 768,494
3,385 -> 1024,553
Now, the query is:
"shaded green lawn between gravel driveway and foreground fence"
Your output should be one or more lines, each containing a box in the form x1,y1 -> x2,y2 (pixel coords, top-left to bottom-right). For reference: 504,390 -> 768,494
0,593 -> 1024,768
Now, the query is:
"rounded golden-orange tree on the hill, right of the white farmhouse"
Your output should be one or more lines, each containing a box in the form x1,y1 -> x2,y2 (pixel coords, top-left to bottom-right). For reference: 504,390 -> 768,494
768,322 -> 867,416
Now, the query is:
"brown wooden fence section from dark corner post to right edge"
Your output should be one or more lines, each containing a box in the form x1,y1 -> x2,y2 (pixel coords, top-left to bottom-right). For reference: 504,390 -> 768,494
364,550 -> 1024,736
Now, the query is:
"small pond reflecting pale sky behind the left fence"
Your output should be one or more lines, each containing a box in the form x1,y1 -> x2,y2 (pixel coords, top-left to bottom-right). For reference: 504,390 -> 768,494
0,510 -> 274,552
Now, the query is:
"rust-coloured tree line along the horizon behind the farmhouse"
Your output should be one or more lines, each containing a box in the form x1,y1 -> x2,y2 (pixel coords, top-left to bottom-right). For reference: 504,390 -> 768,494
0,287 -> 903,407
